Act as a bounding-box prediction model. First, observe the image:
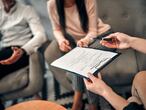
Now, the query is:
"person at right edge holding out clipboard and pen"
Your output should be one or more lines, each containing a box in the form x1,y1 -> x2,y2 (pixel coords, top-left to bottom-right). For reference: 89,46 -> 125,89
84,33 -> 146,110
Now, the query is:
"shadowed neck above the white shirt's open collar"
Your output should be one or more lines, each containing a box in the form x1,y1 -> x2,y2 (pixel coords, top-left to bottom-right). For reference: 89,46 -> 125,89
2,0 -> 16,13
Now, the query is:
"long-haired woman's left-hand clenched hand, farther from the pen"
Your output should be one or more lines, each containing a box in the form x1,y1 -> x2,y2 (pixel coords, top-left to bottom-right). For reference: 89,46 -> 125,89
59,39 -> 71,52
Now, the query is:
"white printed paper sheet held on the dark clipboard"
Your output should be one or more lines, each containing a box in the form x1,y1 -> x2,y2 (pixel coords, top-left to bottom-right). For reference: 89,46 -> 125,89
51,47 -> 119,78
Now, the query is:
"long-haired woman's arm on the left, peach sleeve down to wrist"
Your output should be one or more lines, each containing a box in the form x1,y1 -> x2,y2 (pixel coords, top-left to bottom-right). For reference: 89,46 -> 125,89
47,0 -> 64,42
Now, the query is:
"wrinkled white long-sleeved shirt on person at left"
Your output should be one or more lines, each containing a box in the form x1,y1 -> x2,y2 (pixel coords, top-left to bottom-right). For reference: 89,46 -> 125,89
0,0 -> 47,54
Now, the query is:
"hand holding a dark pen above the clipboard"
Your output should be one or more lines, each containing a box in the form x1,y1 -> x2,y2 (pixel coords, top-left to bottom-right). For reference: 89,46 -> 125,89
100,32 -> 130,49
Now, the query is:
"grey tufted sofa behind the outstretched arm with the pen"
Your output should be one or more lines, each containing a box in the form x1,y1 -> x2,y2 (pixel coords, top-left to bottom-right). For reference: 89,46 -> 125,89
97,0 -> 146,94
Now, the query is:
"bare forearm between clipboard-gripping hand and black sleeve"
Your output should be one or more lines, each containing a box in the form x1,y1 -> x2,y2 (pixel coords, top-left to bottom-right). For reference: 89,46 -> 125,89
103,88 -> 128,110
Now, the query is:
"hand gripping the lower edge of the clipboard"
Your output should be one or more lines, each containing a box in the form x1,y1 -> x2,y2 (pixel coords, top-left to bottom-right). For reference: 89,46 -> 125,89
84,73 -> 110,96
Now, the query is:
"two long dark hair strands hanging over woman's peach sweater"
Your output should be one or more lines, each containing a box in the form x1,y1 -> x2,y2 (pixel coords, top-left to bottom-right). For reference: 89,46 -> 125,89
56,0 -> 89,33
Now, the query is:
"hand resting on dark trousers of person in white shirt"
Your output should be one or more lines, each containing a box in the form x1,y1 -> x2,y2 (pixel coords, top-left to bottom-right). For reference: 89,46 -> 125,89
0,47 -> 24,65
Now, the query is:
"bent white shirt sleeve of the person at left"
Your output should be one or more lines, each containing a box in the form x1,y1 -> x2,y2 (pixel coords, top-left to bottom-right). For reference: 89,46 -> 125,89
22,6 -> 47,54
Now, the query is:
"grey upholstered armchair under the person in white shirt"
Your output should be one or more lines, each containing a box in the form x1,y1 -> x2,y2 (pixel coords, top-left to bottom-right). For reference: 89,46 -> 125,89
0,48 -> 44,101
